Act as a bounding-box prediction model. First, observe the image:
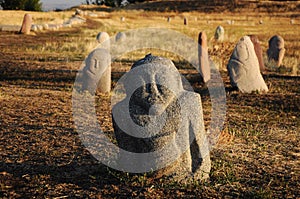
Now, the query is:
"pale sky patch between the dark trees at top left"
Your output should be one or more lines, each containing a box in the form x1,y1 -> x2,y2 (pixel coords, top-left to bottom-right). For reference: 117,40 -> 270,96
40,0 -> 85,11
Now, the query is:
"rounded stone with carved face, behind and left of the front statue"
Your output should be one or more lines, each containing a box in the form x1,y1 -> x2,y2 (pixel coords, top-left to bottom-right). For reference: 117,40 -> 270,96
82,48 -> 111,94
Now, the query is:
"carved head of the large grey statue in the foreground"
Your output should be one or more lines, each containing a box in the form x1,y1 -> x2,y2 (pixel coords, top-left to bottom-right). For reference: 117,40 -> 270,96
125,56 -> 183,115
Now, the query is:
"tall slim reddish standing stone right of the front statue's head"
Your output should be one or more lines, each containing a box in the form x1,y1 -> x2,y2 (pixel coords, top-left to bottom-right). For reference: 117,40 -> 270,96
198,32 -> 210,83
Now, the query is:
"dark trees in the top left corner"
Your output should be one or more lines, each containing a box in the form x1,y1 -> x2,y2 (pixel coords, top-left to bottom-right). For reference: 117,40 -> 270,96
0,0 -> 42,11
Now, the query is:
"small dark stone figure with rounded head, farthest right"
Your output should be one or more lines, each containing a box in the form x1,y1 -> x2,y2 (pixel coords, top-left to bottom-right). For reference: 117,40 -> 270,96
267,35 -> 285,66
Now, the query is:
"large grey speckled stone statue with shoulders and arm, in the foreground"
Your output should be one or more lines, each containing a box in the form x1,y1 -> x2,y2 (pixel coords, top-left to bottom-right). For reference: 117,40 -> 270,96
112,55 -> 211,182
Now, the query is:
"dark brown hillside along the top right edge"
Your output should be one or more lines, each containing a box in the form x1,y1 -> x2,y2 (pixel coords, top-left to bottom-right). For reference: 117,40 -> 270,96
122,0 -> 300,12
